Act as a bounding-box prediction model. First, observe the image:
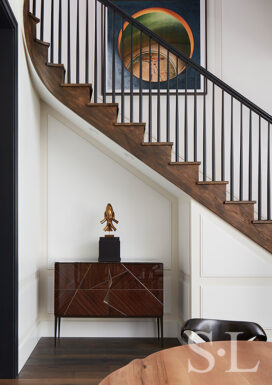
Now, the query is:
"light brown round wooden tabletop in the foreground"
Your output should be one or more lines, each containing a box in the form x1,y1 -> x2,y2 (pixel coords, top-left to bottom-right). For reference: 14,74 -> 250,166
100,341 -> 272,385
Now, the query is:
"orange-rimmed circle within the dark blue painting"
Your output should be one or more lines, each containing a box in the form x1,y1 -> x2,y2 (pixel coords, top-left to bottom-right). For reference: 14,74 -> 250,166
118,8 -> 194,82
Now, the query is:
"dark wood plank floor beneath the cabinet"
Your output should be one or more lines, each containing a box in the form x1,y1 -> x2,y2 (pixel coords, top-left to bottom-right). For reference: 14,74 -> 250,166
0,338 -> 180,385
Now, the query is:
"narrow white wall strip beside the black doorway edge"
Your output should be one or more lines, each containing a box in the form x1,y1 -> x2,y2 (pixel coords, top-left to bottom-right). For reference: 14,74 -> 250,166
7,0 -> 41,370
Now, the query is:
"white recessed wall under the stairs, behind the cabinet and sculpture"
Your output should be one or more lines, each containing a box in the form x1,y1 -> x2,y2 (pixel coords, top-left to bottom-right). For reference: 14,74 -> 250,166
38,105 -> 183,337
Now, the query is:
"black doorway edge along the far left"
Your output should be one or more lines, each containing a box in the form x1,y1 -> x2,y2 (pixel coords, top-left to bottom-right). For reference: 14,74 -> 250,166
0,0 -> 18,378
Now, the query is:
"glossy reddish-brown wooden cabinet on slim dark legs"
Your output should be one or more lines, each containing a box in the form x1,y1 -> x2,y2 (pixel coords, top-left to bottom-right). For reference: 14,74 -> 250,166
55,262 -> 163,335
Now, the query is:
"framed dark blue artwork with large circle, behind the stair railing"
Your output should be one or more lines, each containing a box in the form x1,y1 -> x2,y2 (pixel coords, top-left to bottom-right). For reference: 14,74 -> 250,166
104,0 -> 207,94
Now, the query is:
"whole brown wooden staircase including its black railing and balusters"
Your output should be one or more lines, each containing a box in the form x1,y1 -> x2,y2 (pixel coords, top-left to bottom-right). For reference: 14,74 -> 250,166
24,0 -> 272,253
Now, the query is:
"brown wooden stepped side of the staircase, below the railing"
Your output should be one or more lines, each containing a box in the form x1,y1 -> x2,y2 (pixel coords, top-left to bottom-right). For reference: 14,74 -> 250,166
24,0 -> 272,253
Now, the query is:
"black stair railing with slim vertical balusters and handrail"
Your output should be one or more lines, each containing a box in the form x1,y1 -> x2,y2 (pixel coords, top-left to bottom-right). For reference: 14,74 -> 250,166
30,0 -> 272,220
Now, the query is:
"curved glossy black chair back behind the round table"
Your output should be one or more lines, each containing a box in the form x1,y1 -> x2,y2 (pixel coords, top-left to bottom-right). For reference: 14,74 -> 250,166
181,318 -> 267,344
